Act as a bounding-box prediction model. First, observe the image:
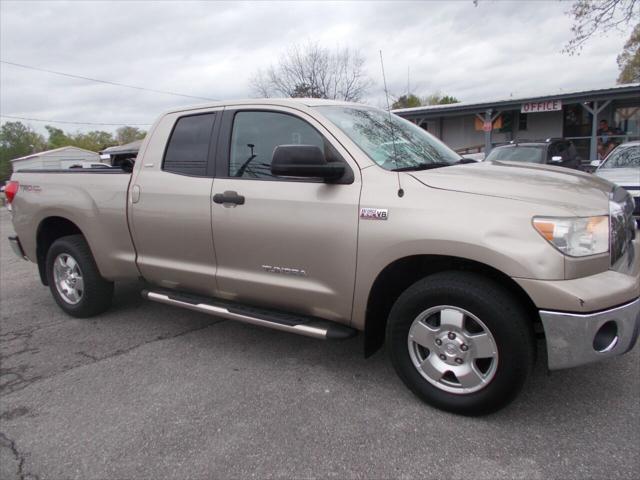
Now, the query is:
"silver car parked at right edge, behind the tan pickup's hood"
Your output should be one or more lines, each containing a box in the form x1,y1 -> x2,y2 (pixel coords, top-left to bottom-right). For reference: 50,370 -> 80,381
592,141 -> 640,227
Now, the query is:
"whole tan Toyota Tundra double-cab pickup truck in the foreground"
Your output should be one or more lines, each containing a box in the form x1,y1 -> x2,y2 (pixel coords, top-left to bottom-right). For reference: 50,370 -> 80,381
7,99 -> 640,415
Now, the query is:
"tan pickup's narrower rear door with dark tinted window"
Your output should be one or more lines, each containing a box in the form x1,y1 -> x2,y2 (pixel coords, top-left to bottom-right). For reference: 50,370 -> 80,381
129,110 -> 221,295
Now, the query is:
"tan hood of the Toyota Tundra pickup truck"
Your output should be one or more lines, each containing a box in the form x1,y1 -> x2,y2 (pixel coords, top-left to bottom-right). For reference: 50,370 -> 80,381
410,161 -> 613,216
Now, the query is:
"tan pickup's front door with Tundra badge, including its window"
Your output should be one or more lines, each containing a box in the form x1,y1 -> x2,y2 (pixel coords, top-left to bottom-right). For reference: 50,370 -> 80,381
212,107 -> 360,321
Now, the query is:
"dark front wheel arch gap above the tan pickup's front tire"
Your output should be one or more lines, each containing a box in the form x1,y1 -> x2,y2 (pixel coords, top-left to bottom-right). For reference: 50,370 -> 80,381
364,255 -> 539,357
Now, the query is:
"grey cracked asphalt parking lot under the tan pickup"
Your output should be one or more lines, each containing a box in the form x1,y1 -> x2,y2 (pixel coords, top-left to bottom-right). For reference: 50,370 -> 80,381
0,209 -> 640,479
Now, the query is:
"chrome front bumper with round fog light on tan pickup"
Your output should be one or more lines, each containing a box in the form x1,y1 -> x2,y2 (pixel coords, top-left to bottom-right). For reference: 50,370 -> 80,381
540,298 -> 640,370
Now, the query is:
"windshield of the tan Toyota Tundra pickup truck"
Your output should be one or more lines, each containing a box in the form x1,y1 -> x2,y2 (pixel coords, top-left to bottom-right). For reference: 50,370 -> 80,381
316,106 -> 461,170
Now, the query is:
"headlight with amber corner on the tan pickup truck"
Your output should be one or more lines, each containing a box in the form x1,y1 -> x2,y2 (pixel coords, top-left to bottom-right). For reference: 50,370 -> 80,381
533,215 -> 609,257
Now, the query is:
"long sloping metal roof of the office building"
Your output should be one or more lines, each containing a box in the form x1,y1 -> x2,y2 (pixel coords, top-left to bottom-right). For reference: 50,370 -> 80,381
392,83 -> 640,118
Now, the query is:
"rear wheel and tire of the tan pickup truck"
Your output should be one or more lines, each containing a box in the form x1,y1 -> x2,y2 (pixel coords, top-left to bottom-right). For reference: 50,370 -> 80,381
46,235 -> 113,318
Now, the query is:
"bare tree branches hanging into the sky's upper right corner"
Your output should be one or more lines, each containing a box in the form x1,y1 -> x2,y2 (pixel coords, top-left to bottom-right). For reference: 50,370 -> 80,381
563,0 -> 640,55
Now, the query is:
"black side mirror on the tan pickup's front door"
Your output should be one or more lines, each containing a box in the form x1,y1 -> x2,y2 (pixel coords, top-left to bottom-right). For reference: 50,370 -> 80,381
271,145 -> 345,180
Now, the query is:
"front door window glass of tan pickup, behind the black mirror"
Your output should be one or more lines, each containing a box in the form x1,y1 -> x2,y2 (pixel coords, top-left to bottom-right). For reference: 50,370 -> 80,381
229,112 -> 336,179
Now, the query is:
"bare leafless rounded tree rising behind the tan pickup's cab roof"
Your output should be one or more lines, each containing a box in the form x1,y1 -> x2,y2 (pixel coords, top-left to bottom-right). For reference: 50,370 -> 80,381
251,43 -> 372,102
